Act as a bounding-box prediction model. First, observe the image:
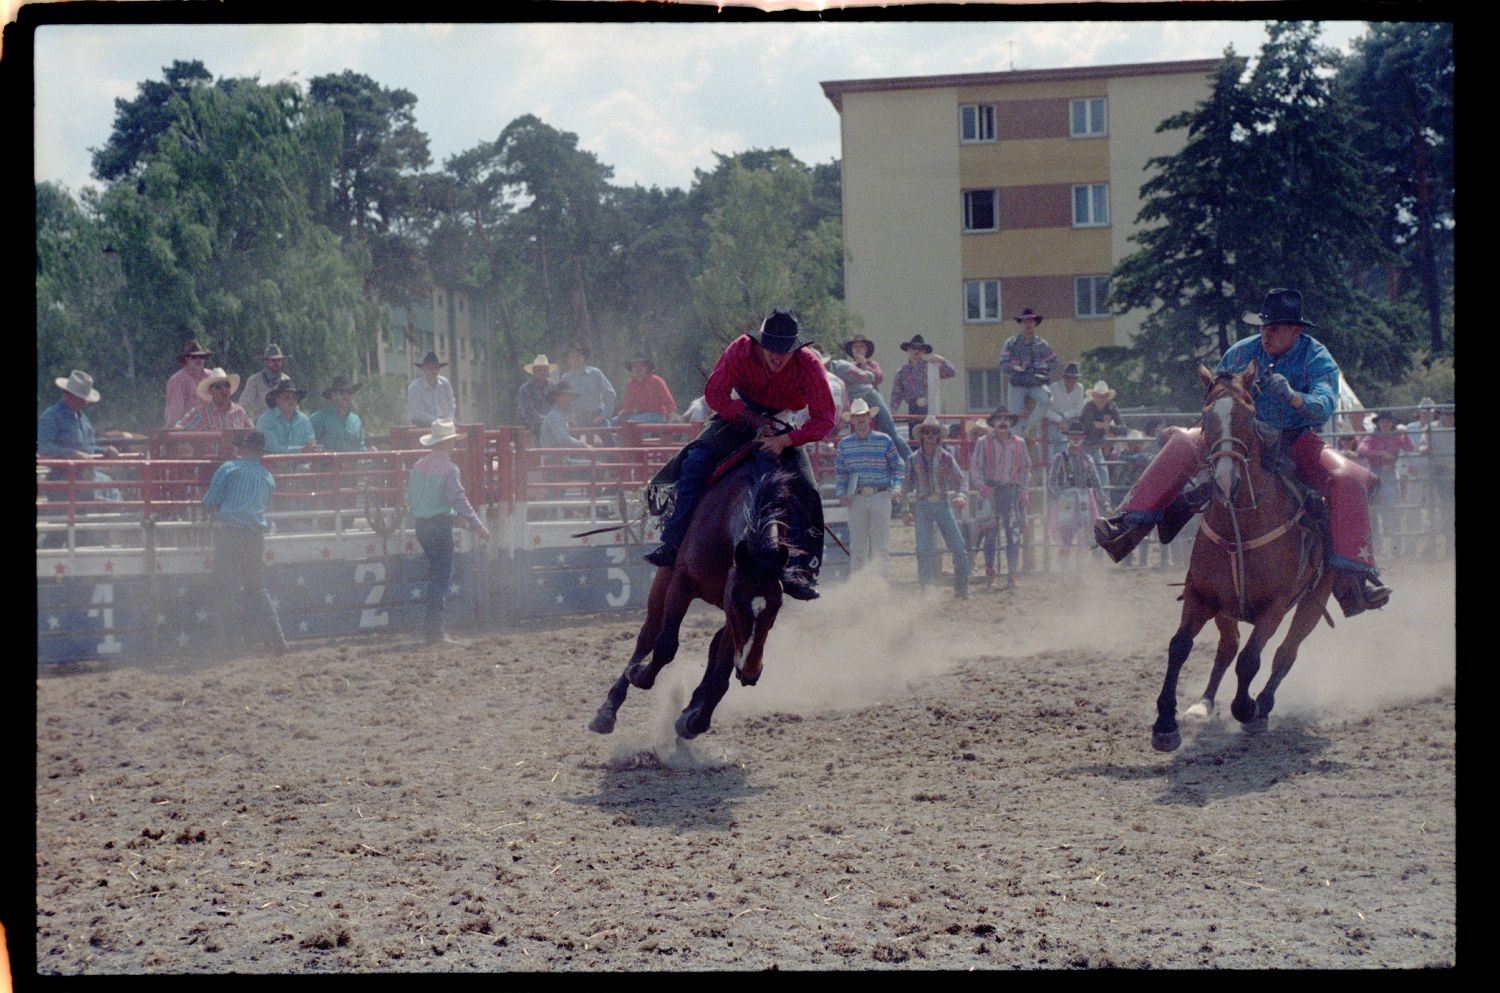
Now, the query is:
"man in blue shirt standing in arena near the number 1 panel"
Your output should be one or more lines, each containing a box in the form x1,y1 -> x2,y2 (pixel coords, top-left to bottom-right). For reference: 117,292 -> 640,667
203,431 -> 287,656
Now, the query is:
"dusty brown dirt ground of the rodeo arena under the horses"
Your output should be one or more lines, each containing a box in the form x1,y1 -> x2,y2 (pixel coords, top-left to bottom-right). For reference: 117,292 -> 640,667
32,560 -> 1457,977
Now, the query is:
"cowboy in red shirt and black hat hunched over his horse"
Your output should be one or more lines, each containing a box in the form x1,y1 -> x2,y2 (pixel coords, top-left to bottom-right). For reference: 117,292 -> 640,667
645,311 -> 836,600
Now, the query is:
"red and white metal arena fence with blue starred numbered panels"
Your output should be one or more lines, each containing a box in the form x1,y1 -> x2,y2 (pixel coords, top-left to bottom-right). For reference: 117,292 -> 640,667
36,413 -> 1454,663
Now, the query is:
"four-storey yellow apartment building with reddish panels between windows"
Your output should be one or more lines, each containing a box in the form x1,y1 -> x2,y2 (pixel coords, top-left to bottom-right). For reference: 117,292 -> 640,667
822,60 -> 1220,413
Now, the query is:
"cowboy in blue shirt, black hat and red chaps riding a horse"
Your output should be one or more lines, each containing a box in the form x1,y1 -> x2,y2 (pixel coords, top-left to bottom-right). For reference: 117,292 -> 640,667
1094,290 -> 1391,617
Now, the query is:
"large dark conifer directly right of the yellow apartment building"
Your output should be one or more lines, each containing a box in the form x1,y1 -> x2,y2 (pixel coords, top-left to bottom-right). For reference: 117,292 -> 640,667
1112,23 -> 1410,404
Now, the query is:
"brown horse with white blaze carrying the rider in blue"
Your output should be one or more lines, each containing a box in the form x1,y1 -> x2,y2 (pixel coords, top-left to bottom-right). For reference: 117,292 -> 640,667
1151,363 -> 1334,752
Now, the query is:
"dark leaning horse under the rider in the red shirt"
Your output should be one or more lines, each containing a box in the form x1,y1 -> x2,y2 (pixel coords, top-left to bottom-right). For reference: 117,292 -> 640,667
588,464 -> 792,738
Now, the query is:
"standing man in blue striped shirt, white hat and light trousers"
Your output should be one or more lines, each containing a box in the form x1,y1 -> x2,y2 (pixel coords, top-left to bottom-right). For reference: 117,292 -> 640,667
834,399 -> 903,579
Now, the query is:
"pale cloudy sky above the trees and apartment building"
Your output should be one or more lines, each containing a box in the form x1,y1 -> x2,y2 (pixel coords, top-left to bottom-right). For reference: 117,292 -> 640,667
35,15 -> 1364,192
